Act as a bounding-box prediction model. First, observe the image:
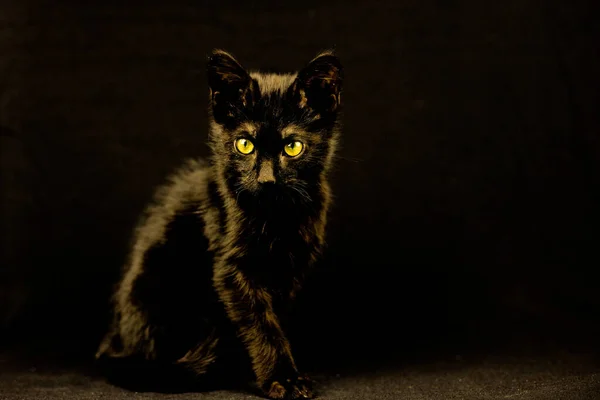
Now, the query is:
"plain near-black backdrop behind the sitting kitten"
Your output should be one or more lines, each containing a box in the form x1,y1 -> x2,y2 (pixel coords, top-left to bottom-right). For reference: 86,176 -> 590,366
0,0 -> 600,376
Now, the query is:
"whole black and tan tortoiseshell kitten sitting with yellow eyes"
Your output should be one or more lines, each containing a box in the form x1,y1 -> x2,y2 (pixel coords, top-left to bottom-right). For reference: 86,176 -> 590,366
96,50 -> 343,399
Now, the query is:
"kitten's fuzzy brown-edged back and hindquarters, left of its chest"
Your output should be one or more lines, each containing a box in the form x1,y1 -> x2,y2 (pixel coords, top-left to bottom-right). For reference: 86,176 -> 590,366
98,159 -> 221,360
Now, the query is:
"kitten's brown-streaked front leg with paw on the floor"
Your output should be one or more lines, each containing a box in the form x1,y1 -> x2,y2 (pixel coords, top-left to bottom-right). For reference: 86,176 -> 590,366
214,266 -> 316,399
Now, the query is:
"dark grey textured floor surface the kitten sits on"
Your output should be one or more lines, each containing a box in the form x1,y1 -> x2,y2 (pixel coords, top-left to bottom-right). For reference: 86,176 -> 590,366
0,355 -> 600,400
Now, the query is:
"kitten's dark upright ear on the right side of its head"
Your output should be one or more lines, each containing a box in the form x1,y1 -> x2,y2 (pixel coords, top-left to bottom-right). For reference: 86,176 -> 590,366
290,51 -> 343,116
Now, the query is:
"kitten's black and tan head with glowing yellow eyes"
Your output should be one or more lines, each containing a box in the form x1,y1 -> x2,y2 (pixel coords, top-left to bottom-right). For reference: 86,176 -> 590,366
208,50 -> 342,206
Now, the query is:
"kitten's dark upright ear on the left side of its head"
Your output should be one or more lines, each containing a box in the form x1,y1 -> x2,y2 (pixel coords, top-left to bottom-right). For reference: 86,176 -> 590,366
207,49 -> 254,123
